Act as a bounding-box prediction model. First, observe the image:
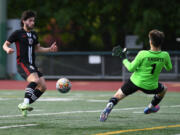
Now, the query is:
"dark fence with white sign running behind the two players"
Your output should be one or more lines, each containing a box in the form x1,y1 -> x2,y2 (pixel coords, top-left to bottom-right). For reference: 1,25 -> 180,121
37,51 -> 180,80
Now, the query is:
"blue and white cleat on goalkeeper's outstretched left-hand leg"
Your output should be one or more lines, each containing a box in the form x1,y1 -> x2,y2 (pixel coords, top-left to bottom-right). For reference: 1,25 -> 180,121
100,103 -> 113,122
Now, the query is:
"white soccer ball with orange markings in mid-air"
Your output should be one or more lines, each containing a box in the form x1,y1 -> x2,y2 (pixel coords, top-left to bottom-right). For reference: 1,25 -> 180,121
56,78 -> 71,93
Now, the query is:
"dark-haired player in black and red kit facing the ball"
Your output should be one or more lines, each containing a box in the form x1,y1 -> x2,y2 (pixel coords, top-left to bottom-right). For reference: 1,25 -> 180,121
3,10 -> 57,116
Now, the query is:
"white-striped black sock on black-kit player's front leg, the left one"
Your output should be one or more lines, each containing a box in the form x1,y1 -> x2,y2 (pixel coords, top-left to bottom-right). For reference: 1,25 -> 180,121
24,82 -> 37,103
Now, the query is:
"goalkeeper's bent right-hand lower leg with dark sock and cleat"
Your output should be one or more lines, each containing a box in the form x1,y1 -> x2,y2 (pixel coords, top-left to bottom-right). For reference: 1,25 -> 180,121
144,83 -> 167,114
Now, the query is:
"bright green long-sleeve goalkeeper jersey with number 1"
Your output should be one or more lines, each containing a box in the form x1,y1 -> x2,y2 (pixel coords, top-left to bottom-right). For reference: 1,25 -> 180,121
123,50 -> 172,90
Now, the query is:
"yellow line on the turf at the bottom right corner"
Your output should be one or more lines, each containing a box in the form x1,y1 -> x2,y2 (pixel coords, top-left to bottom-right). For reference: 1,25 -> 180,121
94,125 -> 180,135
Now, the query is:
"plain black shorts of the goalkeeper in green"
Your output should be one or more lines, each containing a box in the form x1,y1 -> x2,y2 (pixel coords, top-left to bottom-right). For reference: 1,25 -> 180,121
121,79 -> 164,96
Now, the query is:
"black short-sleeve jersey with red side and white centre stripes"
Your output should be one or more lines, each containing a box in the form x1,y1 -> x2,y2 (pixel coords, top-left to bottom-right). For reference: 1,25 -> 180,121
7,29 -> 39,65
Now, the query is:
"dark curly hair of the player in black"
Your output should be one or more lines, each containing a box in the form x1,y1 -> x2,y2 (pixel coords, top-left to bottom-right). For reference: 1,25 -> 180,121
21,10 -> 36,27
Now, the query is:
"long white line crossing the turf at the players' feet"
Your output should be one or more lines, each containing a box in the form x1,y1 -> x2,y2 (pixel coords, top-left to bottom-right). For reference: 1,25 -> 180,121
0,105 -> 180,118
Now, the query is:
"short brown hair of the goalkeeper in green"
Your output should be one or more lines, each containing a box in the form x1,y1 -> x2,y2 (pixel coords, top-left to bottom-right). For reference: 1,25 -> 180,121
149,29 -> 165,47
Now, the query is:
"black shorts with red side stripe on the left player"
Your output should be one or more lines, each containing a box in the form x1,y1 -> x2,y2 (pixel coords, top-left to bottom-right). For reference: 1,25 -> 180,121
18,62 -> 43,80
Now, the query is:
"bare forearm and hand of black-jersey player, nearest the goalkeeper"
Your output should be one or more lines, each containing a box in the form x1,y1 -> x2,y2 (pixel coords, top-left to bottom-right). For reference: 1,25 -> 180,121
36,42 -> 57,52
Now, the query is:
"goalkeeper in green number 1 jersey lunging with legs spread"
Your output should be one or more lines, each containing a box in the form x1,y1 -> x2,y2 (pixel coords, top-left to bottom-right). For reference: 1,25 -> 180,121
100,30 -> 172,122
